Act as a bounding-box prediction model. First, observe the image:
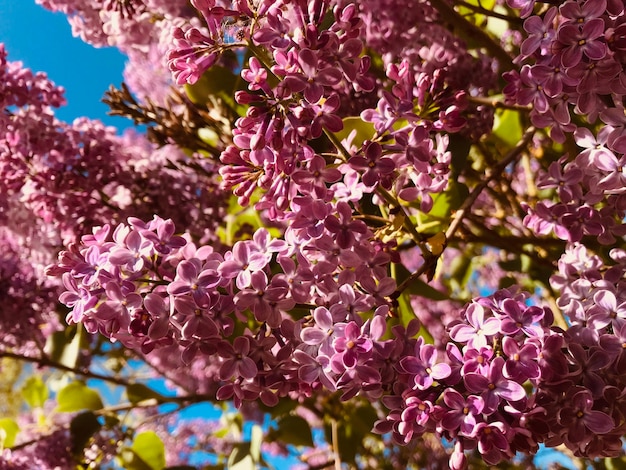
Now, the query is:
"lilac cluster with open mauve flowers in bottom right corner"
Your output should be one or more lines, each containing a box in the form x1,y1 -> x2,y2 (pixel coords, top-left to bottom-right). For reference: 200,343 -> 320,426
375,290 -> 624,468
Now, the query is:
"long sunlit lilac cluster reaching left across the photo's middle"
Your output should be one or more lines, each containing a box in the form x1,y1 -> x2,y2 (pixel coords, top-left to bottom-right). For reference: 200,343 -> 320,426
48,217 -> 395,405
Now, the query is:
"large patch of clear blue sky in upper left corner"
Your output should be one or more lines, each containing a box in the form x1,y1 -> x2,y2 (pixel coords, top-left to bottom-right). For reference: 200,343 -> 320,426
0,0 -> 132,128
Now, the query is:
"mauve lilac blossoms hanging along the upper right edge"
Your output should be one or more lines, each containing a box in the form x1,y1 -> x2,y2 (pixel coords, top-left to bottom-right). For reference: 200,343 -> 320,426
504,0 -> 626,245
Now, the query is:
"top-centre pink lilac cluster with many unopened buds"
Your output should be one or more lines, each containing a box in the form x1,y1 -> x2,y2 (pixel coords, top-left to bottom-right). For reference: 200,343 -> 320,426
168,1 -> 498,224
